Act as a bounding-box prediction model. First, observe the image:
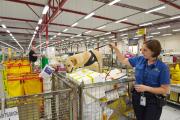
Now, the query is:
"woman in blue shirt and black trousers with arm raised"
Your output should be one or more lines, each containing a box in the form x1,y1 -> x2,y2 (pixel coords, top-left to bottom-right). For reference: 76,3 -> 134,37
110,40 -> 170,120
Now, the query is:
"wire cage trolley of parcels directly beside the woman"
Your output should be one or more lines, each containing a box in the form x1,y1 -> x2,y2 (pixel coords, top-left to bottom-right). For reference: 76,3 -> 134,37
54,74 -> 135,120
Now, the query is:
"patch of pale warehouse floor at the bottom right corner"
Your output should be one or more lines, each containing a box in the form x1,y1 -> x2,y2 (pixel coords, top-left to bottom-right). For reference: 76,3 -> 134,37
160,106 -> 180,120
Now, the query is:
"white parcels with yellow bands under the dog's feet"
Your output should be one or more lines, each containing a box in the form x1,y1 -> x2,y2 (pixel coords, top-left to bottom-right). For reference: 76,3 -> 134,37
67,69 -> 105,84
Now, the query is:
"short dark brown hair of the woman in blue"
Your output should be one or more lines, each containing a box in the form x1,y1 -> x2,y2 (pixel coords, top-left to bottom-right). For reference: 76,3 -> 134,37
144,40 -> 161,57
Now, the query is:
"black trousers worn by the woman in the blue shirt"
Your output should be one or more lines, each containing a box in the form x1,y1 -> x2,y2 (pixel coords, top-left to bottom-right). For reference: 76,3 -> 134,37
132,92 -> 162,120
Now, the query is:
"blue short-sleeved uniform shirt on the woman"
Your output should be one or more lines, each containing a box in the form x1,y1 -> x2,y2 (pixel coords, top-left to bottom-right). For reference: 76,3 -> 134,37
129,56 -> 170,87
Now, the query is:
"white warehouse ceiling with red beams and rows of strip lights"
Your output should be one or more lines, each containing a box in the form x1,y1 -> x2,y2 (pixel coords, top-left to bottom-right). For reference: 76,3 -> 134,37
0,0 -> 180,50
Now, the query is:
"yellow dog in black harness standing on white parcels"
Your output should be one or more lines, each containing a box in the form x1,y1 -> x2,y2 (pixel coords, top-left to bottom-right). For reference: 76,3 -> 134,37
65,50 -> 102,72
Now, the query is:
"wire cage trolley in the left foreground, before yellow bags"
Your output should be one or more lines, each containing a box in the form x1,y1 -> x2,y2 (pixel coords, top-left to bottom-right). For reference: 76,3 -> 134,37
0,86 -> 74,120
